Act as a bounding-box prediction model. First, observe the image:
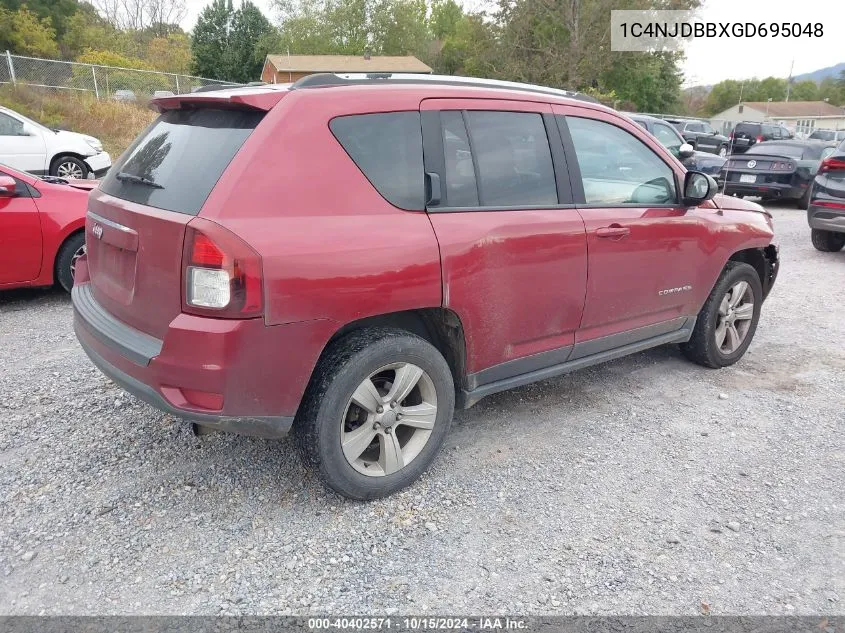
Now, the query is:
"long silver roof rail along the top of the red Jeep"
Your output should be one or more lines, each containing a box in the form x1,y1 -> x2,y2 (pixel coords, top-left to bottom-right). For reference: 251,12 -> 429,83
290,73 -> 599,103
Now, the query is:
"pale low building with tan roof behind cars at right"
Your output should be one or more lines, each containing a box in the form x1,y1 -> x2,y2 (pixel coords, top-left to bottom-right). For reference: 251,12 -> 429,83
711,101 -> 845,136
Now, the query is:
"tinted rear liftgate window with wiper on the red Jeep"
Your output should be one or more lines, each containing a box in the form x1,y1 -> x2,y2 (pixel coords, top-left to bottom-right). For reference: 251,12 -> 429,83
100,108 -> 264,215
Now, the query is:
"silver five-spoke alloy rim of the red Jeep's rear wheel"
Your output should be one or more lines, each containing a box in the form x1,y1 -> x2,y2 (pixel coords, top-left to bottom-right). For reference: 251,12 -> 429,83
341,363 -> 437,477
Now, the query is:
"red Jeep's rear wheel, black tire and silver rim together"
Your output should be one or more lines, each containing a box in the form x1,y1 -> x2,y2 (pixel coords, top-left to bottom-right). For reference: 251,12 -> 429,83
295,328 -> 455,500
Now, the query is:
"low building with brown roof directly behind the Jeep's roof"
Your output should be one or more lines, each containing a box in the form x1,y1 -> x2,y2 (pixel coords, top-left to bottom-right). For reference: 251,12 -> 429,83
261,55 -> 431,84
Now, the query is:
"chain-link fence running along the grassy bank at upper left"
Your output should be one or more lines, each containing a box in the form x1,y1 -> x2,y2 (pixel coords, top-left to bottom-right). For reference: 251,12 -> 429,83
0,51 -> 236,101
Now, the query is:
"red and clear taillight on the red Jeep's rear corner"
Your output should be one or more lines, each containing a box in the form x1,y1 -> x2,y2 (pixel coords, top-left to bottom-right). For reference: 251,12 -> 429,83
182,218 -> 264,319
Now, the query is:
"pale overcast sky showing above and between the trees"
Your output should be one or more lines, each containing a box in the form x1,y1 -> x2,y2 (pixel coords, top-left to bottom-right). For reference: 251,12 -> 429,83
182,0 -> 845,86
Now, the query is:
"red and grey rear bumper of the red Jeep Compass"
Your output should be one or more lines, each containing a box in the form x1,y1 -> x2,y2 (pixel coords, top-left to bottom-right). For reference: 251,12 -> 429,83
71,283 -> 301,437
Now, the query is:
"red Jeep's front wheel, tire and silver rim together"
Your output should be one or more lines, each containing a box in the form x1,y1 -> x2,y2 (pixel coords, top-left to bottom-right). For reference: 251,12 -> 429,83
681,261 -> 763,369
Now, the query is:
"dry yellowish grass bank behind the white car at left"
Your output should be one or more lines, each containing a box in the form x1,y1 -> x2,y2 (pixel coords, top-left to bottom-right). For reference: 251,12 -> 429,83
0,85 -> 157,161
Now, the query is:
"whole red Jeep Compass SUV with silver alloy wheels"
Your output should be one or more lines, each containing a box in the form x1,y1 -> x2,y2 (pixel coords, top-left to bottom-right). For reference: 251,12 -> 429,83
73,75 -> 778,499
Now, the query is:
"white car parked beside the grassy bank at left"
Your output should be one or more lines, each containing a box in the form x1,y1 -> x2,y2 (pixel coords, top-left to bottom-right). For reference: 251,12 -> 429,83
0,106 -> 111,178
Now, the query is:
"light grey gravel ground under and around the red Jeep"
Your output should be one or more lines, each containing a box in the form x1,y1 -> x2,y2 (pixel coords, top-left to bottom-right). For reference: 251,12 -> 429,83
0,206 -> 845,614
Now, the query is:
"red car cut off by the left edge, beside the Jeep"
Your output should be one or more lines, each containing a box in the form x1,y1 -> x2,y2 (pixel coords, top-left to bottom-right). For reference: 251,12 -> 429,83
0,165 -> 97,292
